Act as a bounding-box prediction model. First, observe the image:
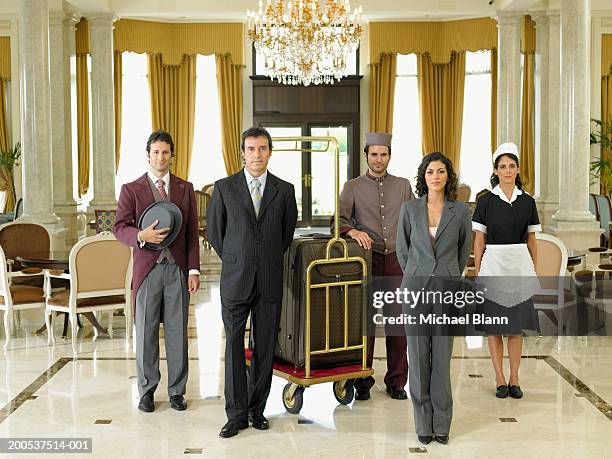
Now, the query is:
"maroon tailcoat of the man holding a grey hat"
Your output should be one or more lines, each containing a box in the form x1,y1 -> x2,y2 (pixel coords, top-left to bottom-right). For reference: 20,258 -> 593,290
113,174 -> 200,297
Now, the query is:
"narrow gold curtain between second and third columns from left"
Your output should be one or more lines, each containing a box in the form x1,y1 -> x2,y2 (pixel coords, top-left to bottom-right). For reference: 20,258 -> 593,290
76,54 -> 89,196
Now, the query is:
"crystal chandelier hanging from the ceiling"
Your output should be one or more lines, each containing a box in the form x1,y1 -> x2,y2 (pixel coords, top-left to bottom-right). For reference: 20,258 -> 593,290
247,0 -> 363,86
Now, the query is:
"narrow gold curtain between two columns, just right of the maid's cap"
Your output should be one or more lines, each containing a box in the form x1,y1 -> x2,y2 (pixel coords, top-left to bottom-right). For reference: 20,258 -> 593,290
519,53 -> 535,195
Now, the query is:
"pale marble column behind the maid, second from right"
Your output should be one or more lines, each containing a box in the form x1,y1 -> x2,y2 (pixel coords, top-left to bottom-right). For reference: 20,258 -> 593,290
531,11 -> 561,226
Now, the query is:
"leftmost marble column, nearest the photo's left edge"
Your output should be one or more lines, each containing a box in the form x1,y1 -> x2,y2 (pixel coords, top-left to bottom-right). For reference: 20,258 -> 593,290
19,0 -> 59,225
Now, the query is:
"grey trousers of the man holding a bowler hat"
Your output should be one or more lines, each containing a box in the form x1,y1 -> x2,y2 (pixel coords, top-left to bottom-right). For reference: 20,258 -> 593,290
135,261 -> 189,397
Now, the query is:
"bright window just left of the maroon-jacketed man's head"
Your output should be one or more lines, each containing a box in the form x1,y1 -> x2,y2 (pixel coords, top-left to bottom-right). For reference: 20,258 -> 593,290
115,53 -> 151,198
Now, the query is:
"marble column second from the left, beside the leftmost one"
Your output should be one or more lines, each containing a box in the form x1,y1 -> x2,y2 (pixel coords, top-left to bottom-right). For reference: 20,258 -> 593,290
49,12 -> 79,244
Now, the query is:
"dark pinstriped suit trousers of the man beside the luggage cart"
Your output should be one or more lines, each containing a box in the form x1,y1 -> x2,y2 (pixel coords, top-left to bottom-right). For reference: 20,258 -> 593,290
221,280 -> 281,421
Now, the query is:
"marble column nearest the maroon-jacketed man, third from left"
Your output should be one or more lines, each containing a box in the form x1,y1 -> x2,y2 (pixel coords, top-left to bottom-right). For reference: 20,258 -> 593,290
88,14 -> 117,212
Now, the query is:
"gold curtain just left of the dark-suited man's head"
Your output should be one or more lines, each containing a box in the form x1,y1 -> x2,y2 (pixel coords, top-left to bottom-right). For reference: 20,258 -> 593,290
215,54 -> 242,175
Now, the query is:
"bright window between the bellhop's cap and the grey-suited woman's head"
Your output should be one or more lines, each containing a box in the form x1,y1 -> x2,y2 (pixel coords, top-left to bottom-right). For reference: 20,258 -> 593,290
389,54 -> 423,190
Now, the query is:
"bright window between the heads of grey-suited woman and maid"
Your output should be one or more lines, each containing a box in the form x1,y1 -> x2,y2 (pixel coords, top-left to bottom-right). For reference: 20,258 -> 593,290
459,51 -> 493,201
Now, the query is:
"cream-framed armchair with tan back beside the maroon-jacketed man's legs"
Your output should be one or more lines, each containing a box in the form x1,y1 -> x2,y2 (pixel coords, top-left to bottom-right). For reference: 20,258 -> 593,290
45,233 -> 132,357
